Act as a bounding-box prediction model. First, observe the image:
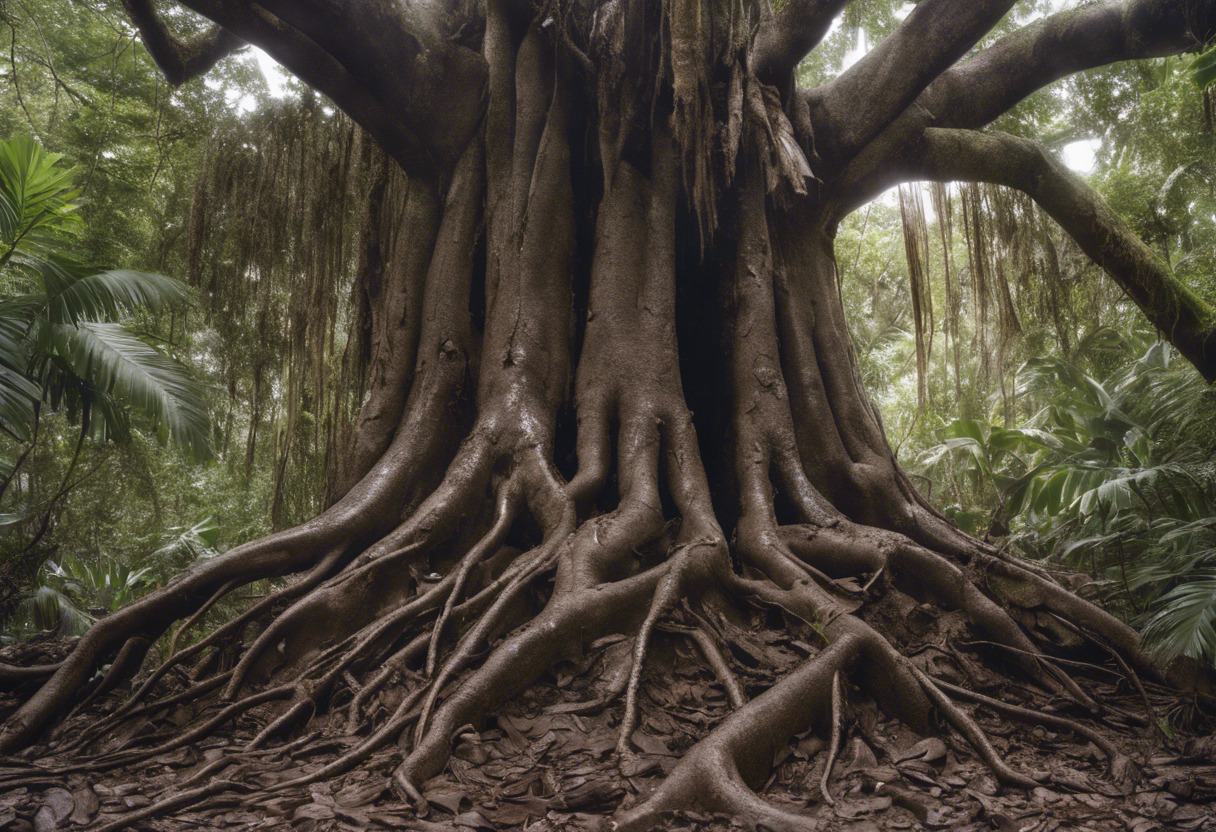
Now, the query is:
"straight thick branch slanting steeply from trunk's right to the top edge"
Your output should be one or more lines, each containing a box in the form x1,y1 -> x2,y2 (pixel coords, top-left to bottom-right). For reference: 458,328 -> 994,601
804,0 -> 1013,169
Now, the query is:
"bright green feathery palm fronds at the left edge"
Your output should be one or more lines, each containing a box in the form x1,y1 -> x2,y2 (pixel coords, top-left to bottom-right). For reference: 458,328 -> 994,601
0,137 -> 210,456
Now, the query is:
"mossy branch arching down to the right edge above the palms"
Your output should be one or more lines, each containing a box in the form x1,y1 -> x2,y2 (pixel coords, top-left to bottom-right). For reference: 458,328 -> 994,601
907,128 -> 1216,381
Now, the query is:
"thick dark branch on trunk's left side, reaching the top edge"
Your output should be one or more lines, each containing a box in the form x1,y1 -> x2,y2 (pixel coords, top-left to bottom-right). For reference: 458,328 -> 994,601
182,0 -> 486,178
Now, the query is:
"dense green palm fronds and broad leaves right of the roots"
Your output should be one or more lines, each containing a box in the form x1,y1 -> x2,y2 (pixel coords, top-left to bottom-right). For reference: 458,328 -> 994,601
919,333 -> 1216,660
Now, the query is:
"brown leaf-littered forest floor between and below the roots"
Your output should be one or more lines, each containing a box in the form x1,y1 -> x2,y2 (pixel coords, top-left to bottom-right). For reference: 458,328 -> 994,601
0,603 -> 1216,832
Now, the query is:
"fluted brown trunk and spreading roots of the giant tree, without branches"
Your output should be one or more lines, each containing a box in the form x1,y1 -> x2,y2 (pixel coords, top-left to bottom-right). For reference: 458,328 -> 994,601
0,14 -> 1201,831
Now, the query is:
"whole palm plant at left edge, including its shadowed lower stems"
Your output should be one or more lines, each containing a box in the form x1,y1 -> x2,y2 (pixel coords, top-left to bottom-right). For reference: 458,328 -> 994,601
0,136 -> 210,617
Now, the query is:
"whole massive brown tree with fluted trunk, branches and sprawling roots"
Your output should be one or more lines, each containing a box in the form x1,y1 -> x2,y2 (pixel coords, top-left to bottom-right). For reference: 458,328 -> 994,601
0,0 -> 1216,830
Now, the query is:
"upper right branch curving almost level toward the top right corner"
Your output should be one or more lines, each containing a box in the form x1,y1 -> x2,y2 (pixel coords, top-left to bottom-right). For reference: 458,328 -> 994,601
917,0 -> 1216,128
